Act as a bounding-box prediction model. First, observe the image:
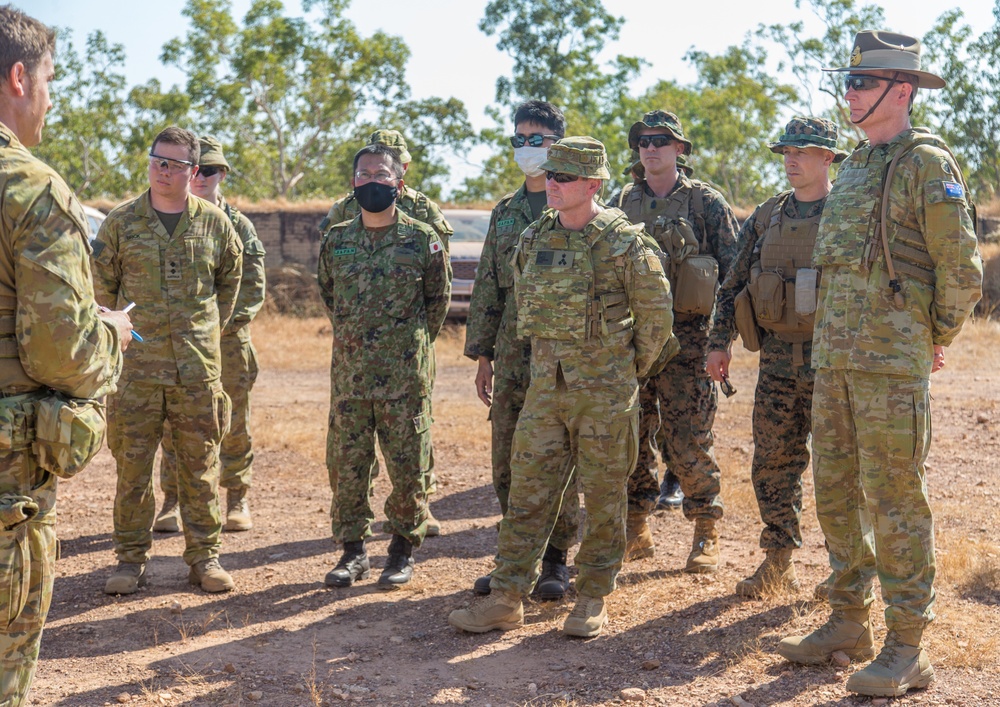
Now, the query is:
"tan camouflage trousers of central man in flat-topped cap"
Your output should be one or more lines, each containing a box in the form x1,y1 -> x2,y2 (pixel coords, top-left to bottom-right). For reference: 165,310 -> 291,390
490,377 -> 639,597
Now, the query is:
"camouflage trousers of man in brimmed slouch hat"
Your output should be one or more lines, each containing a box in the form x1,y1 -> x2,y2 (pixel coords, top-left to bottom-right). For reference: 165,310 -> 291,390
812,368 -> 935,630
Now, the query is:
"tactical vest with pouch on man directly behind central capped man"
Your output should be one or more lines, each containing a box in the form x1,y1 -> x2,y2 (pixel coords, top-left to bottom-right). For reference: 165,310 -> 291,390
619,181 -> 719,317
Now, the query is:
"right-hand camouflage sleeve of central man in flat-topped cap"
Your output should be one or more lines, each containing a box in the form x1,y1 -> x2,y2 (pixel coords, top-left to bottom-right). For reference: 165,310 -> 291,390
625,231 -> 674,378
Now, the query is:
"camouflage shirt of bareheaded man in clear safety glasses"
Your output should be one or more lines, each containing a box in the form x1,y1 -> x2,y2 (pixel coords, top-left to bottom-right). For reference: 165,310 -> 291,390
93,191 -> 243,385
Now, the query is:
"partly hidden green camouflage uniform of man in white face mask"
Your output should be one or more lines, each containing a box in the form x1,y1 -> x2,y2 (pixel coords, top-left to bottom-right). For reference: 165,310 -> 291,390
465,185 -> 580,550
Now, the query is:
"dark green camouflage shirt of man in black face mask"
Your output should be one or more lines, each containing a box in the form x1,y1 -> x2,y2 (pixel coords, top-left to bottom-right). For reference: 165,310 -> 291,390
318,210 -> 451,400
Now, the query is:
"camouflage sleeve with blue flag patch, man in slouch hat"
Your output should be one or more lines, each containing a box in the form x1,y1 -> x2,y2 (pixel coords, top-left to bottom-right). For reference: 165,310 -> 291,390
912,146 -> 983,346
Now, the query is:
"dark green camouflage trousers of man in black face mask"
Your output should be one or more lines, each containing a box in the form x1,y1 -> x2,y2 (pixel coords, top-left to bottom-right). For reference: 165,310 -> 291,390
326,396 -> 431,547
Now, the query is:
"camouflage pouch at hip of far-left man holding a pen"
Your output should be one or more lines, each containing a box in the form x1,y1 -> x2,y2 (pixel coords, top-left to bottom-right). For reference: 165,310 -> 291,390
34,393 -> 107,479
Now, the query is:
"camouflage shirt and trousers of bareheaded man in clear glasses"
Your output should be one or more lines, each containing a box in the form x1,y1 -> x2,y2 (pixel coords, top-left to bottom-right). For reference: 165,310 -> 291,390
93,191 -> 243,565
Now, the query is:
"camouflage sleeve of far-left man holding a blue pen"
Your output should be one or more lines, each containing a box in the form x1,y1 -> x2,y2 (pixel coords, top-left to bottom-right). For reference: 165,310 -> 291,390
13,180 -> 122,398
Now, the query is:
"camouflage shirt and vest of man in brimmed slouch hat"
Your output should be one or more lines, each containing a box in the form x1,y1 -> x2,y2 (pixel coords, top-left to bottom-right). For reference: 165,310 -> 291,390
813,129 -> 983,378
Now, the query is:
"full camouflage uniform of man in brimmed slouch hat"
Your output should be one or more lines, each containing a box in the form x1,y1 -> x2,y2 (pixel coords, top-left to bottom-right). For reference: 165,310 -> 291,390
812,129 -> 982,631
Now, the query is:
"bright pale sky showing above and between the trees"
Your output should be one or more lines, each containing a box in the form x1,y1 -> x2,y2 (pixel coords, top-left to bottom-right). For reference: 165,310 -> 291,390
27,0 -> 994,195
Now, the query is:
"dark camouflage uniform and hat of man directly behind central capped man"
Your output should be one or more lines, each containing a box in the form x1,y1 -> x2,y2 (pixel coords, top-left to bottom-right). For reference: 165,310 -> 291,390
618,116 -> 739,519
